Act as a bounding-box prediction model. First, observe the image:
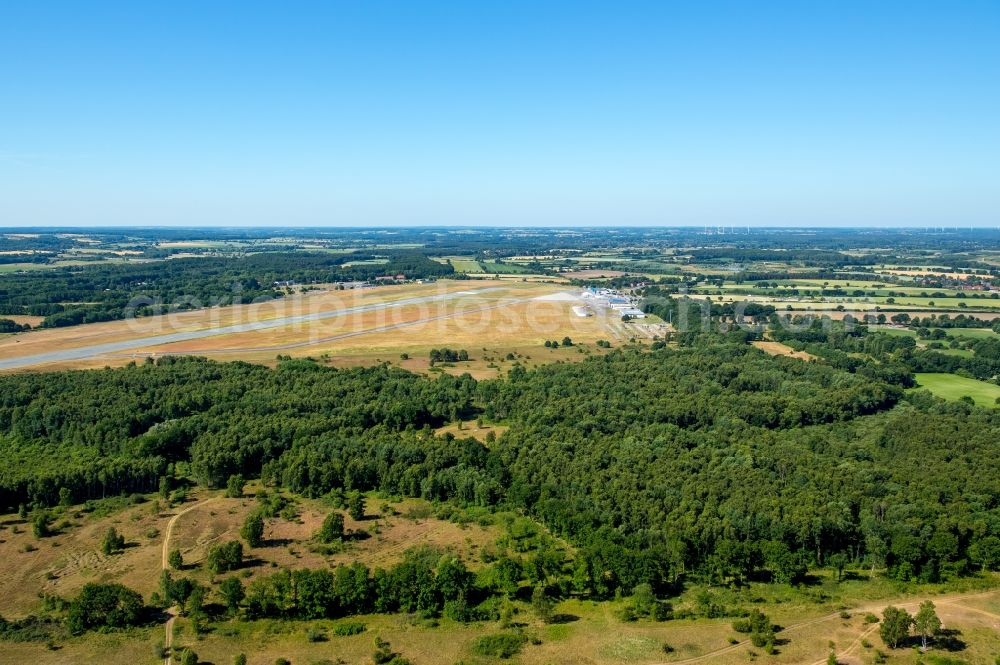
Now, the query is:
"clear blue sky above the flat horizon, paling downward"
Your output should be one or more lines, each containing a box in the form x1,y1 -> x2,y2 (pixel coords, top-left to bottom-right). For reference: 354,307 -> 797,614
0,0 -> 1000,226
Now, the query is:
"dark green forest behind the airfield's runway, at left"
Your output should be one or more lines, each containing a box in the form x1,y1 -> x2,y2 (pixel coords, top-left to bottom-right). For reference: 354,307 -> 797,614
0,251 -> 454,327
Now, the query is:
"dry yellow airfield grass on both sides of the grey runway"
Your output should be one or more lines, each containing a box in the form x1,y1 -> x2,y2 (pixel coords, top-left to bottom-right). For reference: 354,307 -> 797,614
0,280 -> 608,376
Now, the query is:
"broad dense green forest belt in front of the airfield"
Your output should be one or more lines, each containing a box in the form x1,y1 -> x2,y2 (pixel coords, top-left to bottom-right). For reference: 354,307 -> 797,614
0,335 -> 1000,596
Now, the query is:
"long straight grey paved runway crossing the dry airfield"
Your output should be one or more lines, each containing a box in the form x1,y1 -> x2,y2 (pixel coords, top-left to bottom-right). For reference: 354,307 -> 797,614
0,286 -> 502,370
